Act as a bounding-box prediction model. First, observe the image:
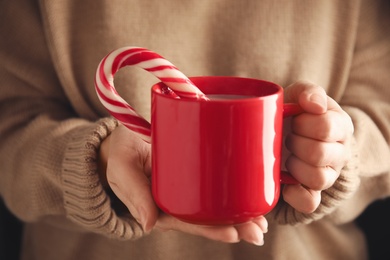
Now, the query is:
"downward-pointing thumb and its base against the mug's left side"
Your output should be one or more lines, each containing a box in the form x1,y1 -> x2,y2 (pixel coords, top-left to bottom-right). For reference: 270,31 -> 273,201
107,126 -> 158,232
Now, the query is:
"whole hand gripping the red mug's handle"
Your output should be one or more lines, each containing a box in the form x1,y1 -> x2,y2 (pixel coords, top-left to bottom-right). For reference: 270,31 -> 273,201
283,82 -> 354,213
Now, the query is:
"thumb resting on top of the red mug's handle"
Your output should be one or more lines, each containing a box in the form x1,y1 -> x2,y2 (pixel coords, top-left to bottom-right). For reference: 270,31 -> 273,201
284,81 -> 328,114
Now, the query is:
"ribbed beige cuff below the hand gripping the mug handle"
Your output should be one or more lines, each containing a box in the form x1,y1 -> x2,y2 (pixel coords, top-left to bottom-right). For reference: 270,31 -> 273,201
269,137 -> 360,225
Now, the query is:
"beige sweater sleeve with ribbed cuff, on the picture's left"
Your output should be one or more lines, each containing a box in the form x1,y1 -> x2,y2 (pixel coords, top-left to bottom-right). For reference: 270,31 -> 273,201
0,1 -> 142,239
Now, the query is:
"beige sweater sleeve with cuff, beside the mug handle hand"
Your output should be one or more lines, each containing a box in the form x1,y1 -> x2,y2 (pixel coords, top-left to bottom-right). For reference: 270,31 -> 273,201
272,1 -> 390,224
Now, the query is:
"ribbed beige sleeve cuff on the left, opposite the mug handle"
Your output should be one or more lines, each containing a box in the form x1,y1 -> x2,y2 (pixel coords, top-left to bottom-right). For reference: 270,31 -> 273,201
62,118 -> 143,240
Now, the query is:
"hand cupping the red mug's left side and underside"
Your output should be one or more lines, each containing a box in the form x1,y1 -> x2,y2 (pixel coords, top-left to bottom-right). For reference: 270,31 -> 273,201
99,125 -> 268,245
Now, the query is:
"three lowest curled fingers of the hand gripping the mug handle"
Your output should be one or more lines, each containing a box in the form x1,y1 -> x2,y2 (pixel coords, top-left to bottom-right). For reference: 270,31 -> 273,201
283,134 -> 349,214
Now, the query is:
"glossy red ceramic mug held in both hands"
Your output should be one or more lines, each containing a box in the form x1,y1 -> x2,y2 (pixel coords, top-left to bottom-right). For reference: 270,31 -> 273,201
152,77 -> 301,225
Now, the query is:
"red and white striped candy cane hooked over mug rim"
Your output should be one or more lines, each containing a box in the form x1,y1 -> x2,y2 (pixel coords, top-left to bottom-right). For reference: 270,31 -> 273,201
95,47 -> 207,142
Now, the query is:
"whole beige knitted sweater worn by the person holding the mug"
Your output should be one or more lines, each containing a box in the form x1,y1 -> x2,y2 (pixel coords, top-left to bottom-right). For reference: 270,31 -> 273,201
0,0 -> 390,260
